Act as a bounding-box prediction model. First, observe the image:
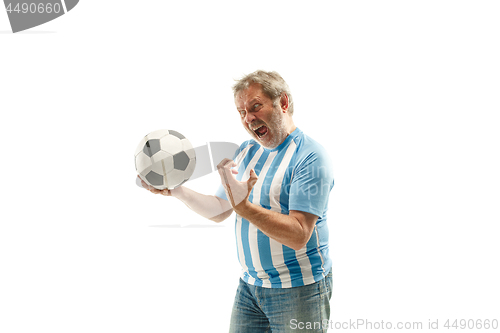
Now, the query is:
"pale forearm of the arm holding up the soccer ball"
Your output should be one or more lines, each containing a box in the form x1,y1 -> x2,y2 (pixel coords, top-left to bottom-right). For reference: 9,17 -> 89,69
171,186 -> 232,222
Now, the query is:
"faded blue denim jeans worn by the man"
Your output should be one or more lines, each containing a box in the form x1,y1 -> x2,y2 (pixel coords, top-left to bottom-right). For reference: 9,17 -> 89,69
229,271 -> 332,333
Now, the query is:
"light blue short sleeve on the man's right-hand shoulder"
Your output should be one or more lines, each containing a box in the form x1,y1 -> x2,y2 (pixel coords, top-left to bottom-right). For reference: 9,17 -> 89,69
288,149 -> 333,217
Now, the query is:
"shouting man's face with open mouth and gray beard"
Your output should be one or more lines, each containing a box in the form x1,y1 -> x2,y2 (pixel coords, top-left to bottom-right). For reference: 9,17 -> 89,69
235,84 -> 289,149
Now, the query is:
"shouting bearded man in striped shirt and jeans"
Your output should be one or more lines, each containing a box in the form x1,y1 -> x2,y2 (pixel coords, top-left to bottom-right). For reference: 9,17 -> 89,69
139,71 -> 333,333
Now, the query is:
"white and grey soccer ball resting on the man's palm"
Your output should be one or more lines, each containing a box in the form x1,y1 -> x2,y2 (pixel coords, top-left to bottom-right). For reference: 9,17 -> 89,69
135,129 -> 196,190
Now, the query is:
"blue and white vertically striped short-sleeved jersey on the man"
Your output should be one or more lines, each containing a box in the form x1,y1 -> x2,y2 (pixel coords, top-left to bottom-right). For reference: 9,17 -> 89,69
215,128 -> 333,288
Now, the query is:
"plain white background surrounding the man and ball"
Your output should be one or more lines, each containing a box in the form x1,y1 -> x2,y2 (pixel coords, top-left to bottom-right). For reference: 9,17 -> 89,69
0,0 -> 500,333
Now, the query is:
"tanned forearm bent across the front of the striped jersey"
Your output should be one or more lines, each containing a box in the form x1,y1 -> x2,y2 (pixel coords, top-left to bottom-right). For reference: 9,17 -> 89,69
236,202 -> 311,250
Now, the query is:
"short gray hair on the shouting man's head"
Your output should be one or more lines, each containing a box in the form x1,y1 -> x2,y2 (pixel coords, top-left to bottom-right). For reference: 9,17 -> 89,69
233,70 -> 293,115
